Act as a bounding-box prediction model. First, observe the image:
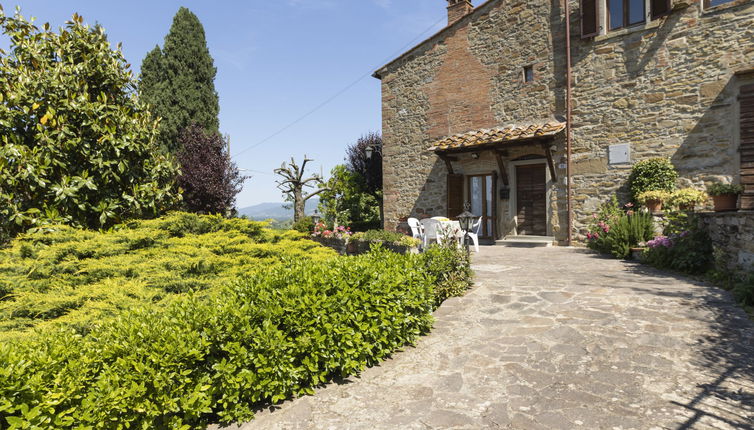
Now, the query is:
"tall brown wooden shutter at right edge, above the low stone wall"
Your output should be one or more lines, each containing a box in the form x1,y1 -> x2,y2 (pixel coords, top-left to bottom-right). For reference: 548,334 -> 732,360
738,84 -> 754,210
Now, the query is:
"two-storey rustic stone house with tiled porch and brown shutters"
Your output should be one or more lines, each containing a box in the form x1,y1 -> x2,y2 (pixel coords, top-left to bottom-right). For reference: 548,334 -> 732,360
374,0 -> 754,243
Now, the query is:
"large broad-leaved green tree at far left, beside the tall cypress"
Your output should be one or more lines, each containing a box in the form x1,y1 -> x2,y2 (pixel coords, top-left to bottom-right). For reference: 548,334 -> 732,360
0,11 -> 180,240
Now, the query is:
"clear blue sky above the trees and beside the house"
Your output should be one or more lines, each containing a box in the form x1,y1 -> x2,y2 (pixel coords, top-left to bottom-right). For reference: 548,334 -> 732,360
0,0 -> 446,207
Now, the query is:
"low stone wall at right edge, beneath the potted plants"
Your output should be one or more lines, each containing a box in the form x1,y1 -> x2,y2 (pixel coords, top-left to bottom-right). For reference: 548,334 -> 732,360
702,211 -> 754,272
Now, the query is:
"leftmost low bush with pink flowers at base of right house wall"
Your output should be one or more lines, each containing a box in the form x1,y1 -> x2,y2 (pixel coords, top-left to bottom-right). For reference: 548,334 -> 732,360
587,196 -> 654,258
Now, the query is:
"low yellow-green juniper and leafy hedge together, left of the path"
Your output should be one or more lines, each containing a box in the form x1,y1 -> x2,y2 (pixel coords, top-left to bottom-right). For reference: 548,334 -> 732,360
0,213 -> 471,428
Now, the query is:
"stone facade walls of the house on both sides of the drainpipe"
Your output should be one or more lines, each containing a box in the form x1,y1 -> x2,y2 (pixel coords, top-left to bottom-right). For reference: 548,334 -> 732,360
380,0 -> 754,239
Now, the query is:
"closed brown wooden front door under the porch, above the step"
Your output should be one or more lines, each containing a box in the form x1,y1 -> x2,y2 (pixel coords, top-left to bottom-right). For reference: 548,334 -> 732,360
516,163 -> 547,236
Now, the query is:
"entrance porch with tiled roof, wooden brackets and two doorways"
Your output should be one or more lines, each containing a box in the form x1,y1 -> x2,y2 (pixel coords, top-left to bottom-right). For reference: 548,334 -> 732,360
430,122 -> 565,245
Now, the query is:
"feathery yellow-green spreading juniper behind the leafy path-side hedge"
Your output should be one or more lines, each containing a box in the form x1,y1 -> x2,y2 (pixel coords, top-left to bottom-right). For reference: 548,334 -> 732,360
0,213 -> 335,340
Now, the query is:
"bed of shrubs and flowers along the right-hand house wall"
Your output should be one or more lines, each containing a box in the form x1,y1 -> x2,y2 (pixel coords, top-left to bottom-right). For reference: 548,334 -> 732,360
586,158 -> 754,312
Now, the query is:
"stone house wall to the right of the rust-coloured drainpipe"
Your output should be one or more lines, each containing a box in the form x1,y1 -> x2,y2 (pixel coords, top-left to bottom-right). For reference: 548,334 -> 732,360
572,2 -> 754,235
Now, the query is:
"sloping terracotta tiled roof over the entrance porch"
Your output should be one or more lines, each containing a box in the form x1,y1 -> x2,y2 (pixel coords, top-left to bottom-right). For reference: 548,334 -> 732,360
429,121 -> 566,152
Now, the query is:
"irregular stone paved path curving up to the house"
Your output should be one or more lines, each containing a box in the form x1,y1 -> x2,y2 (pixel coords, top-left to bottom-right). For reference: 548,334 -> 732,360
229,247 -> 754,429
